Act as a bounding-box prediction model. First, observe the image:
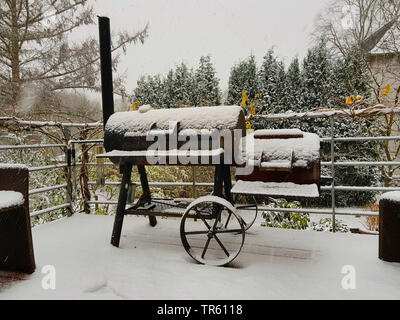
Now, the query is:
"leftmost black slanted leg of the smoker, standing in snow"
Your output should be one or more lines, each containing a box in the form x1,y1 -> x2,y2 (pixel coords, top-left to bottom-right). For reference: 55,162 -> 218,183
111,164 -> 132,247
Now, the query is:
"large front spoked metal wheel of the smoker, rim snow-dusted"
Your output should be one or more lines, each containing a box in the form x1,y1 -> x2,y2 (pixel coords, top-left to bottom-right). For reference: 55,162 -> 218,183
180,196 -> 245,266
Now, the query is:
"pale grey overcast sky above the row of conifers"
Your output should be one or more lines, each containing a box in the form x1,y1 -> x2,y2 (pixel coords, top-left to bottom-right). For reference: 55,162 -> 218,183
92,0 -> 329,92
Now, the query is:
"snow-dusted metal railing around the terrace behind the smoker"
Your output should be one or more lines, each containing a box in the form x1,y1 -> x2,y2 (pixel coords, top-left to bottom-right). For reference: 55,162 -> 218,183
0,109 -> 400,231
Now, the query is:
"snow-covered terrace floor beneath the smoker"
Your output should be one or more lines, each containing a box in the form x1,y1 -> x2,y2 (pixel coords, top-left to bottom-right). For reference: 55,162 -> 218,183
0,214 -> 400,300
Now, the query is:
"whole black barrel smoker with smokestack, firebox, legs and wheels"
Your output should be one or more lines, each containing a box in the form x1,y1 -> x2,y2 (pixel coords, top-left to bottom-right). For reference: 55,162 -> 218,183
98,17 -> 320,266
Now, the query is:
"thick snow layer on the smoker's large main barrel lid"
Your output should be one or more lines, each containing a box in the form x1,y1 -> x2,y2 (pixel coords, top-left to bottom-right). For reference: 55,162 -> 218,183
106,106 -> 244,134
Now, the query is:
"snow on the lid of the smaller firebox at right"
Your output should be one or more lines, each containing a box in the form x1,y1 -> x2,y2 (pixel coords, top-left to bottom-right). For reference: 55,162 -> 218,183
246,130 -> 320,168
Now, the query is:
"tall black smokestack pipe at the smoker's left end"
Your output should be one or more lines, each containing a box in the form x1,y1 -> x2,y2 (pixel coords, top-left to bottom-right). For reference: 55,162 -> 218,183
98,17 -> 114,128
